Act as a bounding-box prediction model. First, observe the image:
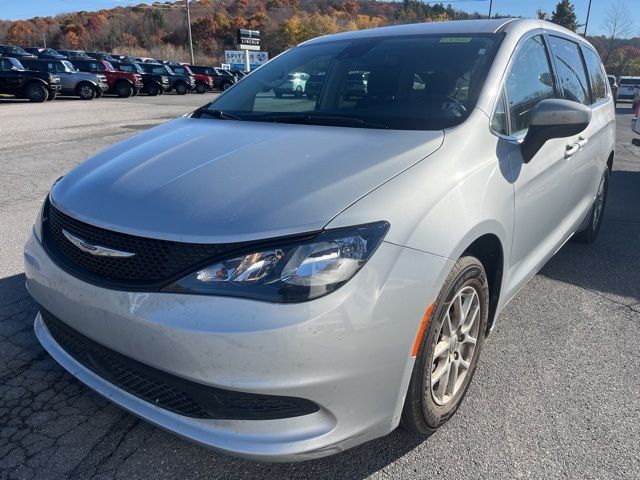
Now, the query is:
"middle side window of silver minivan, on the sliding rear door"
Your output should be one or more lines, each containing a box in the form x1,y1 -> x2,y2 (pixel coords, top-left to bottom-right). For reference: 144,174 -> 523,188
549,35 -> 591,105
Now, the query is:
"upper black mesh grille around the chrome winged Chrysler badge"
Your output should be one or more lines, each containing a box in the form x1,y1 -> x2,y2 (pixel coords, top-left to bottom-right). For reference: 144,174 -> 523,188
42,201 -> 246,288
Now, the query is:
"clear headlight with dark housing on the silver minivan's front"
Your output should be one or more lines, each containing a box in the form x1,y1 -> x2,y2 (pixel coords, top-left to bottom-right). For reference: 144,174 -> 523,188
163,222 -> 389,302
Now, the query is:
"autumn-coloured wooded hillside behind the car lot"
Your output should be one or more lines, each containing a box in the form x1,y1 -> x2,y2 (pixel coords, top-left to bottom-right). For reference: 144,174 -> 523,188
0,0 -> 640,75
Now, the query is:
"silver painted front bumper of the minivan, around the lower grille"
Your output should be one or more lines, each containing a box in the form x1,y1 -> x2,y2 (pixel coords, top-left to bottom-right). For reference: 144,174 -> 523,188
25,232 -> 452,461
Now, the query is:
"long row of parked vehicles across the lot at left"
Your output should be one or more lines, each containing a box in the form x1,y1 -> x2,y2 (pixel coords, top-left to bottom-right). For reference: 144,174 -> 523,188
0,45 -> 245,102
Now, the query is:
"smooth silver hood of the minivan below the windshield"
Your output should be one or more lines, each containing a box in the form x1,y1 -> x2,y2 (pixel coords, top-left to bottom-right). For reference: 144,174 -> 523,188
51,118 -> 444,243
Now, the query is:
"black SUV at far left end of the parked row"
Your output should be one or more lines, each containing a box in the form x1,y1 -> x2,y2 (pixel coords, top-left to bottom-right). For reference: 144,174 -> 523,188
0,57 -> 62,102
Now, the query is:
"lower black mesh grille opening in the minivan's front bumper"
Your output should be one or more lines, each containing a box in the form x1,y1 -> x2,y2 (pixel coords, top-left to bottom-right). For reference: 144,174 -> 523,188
40,309 -> 318,420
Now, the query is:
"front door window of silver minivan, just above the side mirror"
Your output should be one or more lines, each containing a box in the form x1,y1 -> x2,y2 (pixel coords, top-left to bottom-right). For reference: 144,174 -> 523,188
504,35 -> 555,134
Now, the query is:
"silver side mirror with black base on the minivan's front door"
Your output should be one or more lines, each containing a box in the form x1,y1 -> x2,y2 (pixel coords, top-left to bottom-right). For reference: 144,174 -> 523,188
521,99 -> 591,163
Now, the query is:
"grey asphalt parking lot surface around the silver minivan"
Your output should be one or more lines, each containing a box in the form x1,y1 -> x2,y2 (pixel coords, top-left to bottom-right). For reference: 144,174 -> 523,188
0,94 -> 640,479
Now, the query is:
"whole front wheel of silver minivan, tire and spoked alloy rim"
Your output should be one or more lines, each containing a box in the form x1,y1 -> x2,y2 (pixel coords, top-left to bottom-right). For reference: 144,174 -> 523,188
402,256 -> 489,436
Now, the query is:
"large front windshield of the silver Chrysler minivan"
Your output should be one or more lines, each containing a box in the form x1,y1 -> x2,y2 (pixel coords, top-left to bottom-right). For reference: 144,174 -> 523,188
209,34 -> 502,130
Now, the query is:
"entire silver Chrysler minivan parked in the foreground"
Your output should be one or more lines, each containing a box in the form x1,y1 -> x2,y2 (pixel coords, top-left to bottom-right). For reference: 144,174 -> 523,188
24,19 -> 615,461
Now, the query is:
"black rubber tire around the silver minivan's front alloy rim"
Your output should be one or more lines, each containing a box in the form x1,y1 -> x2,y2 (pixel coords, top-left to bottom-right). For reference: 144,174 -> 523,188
401,256 -> 489,436
